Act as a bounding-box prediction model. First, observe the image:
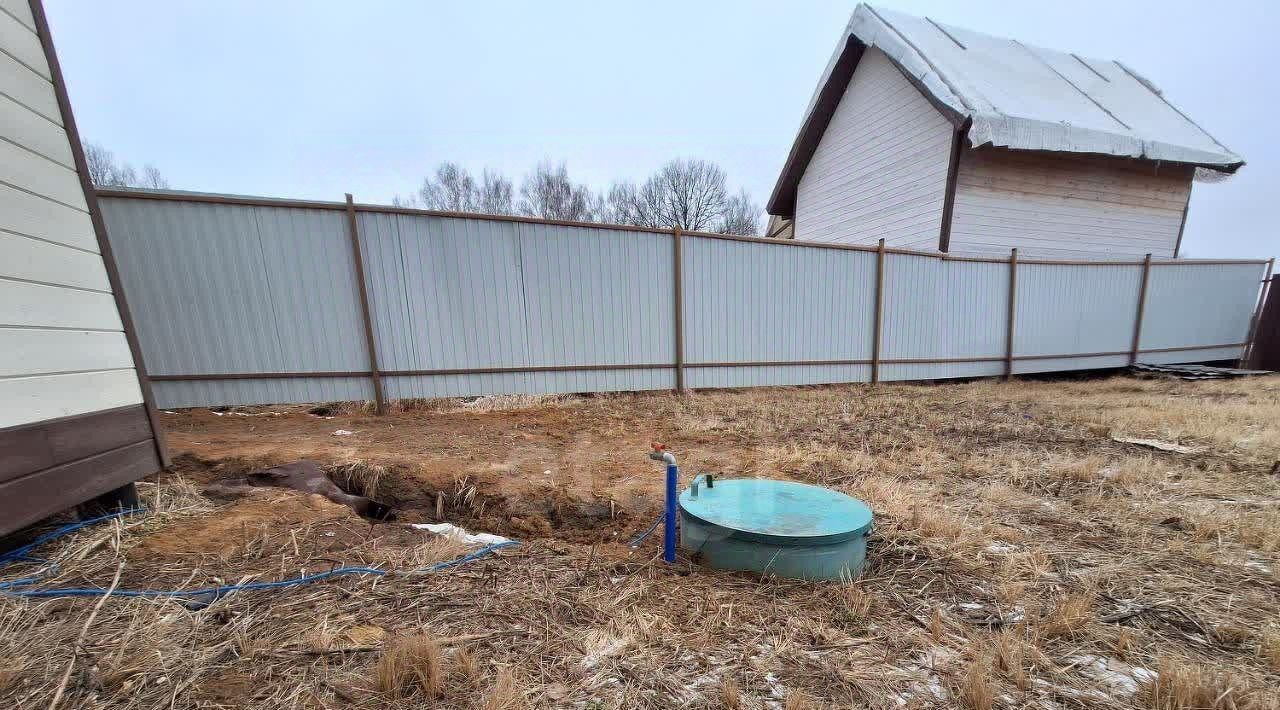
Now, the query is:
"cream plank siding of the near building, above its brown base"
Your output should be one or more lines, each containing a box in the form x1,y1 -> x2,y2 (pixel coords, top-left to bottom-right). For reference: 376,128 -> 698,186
0,0 -> 142,429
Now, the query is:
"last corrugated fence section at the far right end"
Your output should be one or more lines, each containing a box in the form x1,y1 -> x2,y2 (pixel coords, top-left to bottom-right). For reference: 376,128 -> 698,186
1140,264 -> 1266,353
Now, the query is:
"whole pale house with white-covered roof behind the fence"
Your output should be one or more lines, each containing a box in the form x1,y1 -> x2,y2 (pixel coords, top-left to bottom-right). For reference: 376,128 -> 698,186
768,5 -> 1244,260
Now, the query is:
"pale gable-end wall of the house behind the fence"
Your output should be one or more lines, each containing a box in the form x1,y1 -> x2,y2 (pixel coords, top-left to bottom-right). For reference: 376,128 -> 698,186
795,49 -> 952,248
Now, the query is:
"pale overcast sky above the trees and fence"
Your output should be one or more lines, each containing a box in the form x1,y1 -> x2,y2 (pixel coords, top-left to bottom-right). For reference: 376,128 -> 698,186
45,0 -> 1280,257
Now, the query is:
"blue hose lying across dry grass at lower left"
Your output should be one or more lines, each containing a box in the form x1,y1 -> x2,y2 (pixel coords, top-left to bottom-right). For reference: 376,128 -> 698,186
0,509 -> 518,601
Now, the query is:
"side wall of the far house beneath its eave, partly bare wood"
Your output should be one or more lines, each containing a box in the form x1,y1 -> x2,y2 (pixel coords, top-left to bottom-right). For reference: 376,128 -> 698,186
950,150 -> 1192,258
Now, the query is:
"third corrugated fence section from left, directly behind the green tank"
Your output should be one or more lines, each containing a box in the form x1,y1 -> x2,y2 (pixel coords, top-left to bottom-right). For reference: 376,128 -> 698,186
682,237 -> 876,388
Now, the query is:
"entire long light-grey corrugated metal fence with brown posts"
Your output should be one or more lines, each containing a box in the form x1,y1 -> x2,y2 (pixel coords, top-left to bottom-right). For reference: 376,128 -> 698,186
94,191 -> 1265,407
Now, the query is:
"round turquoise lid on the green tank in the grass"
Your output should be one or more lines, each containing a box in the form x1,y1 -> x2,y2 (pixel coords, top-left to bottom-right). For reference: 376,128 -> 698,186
680,478 -> 872,545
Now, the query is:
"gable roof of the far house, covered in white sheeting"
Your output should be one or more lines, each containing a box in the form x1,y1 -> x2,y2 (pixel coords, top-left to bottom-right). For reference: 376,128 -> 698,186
768,5 -> 1244,215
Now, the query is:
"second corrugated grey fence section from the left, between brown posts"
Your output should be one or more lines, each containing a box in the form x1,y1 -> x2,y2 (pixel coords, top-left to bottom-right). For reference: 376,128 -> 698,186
362,215 -> 675,397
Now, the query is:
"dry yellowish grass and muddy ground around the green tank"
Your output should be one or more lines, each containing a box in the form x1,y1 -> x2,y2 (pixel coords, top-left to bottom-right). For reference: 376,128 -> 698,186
0,377 -> 1280,710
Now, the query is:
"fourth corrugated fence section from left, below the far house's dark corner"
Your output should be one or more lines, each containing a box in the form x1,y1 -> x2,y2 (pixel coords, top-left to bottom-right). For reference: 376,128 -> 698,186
881,253 -> 1009,381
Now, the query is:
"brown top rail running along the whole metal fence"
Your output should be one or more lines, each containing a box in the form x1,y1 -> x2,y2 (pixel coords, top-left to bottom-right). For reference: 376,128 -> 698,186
95,187 -> 1267,266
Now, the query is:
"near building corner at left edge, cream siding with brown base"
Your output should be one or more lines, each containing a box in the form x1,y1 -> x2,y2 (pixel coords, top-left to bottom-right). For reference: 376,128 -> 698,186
0,0 -> 164,535
